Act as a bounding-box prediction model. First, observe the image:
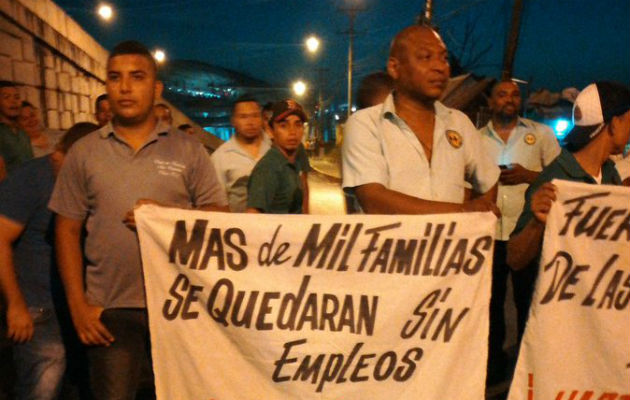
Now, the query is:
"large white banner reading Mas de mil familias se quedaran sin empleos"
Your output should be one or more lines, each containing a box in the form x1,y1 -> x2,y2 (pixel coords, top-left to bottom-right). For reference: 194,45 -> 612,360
136,205 -> 496,400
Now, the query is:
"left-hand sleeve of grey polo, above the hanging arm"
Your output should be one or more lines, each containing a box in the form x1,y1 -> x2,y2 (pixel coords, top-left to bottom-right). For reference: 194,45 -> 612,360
48,144 -> 89,220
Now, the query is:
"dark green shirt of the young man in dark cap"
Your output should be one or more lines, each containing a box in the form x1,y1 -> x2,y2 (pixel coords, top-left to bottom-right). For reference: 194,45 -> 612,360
247,146 -> 303,214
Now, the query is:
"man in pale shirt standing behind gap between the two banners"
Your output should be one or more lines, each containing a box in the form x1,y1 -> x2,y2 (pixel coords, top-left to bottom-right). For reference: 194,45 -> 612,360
480,81 -> 560,384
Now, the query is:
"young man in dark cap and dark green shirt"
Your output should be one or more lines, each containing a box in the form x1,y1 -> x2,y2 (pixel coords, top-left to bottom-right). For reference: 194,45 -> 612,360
247,100 -> 308,214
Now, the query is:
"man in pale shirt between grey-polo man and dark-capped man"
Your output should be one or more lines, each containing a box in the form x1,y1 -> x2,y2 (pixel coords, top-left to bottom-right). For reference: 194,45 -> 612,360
211,94 -> 271,212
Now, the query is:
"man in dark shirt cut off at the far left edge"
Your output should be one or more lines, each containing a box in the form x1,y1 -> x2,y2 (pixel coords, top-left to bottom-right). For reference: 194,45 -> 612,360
0,81 -> 33,181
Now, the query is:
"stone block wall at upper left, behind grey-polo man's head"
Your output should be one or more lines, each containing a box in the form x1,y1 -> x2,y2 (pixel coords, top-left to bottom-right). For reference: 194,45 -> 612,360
0,0 -> 222,149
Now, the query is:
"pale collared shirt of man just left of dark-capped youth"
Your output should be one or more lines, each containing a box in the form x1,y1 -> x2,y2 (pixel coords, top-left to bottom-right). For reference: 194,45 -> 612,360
210,134 -> 271,212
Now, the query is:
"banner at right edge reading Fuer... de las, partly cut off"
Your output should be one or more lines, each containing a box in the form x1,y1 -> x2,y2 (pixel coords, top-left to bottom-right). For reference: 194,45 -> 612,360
508,180 -> 630,400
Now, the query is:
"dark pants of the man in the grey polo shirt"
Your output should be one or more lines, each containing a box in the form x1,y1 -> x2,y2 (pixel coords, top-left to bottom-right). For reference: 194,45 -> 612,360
87,308 -> 151,400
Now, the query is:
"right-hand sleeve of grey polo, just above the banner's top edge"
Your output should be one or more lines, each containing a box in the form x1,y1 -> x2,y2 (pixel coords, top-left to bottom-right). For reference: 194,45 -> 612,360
188,143 -> 227,207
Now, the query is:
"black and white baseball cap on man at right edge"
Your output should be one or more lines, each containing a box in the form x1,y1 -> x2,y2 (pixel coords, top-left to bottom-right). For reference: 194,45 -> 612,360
564,81 -> 630,151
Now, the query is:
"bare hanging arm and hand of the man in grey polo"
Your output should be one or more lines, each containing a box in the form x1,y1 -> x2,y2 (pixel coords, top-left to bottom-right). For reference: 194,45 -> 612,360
55,214 -> 114,346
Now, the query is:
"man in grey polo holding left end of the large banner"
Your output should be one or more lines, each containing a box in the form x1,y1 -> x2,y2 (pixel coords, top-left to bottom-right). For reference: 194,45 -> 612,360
49,41 -> 227,399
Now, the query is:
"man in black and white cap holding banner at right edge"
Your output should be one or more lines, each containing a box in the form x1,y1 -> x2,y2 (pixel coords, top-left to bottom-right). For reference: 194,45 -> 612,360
507,82 -> 630,310
